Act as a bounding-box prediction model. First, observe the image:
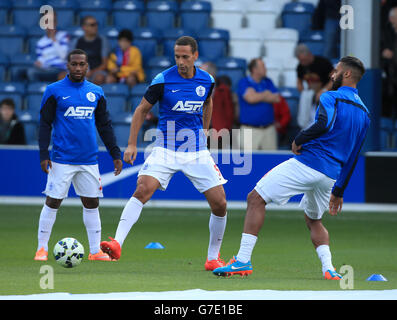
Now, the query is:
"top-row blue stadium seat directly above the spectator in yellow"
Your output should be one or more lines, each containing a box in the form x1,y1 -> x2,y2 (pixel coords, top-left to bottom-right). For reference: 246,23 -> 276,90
113,0 -> 145,30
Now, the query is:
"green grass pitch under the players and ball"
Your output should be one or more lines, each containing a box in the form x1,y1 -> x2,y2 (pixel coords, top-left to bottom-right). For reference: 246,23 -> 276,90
0,206 -> 397,298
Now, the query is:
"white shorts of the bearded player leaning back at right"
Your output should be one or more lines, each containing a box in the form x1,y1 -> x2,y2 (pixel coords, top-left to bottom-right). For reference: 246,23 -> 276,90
255,158 -> 335,220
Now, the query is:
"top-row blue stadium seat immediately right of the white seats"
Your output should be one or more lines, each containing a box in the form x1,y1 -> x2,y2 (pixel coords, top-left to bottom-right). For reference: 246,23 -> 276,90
282,2 -> 314,33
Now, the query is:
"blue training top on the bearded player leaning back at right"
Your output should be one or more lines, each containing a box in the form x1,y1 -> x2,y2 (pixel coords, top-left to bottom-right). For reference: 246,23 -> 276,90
295,87 -> 370,197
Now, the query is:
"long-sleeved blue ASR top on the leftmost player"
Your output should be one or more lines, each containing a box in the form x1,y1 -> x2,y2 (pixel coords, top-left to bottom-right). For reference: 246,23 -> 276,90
39,76 -> 121,165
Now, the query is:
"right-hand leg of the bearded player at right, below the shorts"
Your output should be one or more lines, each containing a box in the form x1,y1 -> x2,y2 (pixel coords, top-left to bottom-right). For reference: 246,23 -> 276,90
305,214 -> 342,280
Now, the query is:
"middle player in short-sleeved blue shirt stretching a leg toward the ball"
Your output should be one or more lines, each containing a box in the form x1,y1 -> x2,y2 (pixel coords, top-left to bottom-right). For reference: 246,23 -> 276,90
101,36 -> 226,270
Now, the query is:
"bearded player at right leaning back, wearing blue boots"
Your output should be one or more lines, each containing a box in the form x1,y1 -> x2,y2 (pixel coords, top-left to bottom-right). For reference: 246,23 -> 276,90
213,56 -> 370,280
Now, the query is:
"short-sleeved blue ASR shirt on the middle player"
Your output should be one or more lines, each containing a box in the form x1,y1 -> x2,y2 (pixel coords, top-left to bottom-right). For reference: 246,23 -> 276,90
144,65 -> 215,152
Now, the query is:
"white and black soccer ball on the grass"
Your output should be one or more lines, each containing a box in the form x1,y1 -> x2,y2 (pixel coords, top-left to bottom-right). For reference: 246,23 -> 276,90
54,238 -> 84,268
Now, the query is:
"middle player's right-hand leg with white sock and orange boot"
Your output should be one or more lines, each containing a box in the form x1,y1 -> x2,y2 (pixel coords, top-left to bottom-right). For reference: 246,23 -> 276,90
204,185 -> 227,271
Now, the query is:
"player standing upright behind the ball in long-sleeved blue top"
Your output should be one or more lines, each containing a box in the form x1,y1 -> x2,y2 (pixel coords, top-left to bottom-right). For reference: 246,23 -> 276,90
34,49 -> 123,261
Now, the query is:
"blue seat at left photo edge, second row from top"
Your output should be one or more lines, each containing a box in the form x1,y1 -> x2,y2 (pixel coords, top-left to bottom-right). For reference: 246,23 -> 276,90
0,25 -> 26,56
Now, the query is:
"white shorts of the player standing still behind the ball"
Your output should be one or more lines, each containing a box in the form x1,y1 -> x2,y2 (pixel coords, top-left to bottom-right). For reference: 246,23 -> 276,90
43,161 -> 103,199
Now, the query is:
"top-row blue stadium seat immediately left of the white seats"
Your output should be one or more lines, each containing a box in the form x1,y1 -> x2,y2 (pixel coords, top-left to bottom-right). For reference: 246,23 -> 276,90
179,1 -> 211,32
